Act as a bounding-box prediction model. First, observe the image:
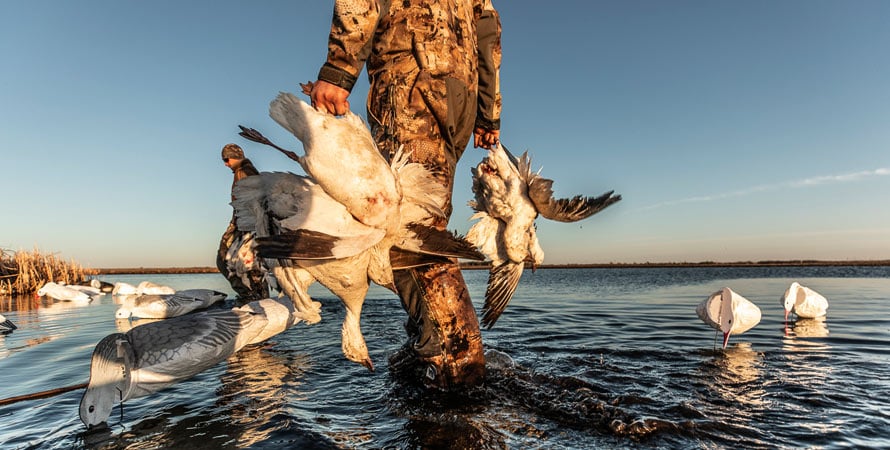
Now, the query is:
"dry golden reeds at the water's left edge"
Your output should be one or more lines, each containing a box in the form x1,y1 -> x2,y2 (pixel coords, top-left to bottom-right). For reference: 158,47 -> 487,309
0,248 -> 90,295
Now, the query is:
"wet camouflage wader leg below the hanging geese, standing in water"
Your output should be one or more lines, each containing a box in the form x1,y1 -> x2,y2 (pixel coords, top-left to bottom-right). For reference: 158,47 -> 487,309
393,264 -> 485,389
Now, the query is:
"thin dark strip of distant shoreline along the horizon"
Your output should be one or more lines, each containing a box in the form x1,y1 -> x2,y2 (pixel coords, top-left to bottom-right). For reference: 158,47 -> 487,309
85,259 -> 890,275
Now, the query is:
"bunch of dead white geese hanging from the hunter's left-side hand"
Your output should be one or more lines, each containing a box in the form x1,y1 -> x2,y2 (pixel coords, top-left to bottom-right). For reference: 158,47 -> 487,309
232,93 -> 483,370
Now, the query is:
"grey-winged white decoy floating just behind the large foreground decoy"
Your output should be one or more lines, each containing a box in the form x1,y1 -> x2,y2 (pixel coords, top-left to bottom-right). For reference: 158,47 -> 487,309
114,289 -> 226,319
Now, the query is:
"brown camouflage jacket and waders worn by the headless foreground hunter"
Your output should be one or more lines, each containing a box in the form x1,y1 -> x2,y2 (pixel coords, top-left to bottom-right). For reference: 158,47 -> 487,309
318,0 -> 501,388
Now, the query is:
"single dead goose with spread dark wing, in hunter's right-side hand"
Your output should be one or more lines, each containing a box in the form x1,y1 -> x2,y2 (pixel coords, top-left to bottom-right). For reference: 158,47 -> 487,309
467,144 -> 621,328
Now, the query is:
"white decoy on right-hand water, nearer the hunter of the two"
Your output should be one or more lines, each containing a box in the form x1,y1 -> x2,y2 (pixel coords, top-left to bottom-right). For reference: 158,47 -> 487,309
695,287 -> 760,348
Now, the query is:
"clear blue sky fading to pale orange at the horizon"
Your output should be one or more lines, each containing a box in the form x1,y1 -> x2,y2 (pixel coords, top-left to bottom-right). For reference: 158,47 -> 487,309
0,0 -> 890,268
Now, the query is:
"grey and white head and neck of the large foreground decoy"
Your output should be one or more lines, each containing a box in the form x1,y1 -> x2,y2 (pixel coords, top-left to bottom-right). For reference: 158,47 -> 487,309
79,333 -> 135,428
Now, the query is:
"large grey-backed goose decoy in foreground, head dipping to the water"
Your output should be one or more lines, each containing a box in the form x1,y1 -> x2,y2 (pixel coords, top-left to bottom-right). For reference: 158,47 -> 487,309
79,299 -> 298,427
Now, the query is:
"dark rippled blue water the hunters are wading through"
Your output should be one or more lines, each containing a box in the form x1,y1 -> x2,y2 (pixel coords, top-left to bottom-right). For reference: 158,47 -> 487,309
0,267 -> 890,449
